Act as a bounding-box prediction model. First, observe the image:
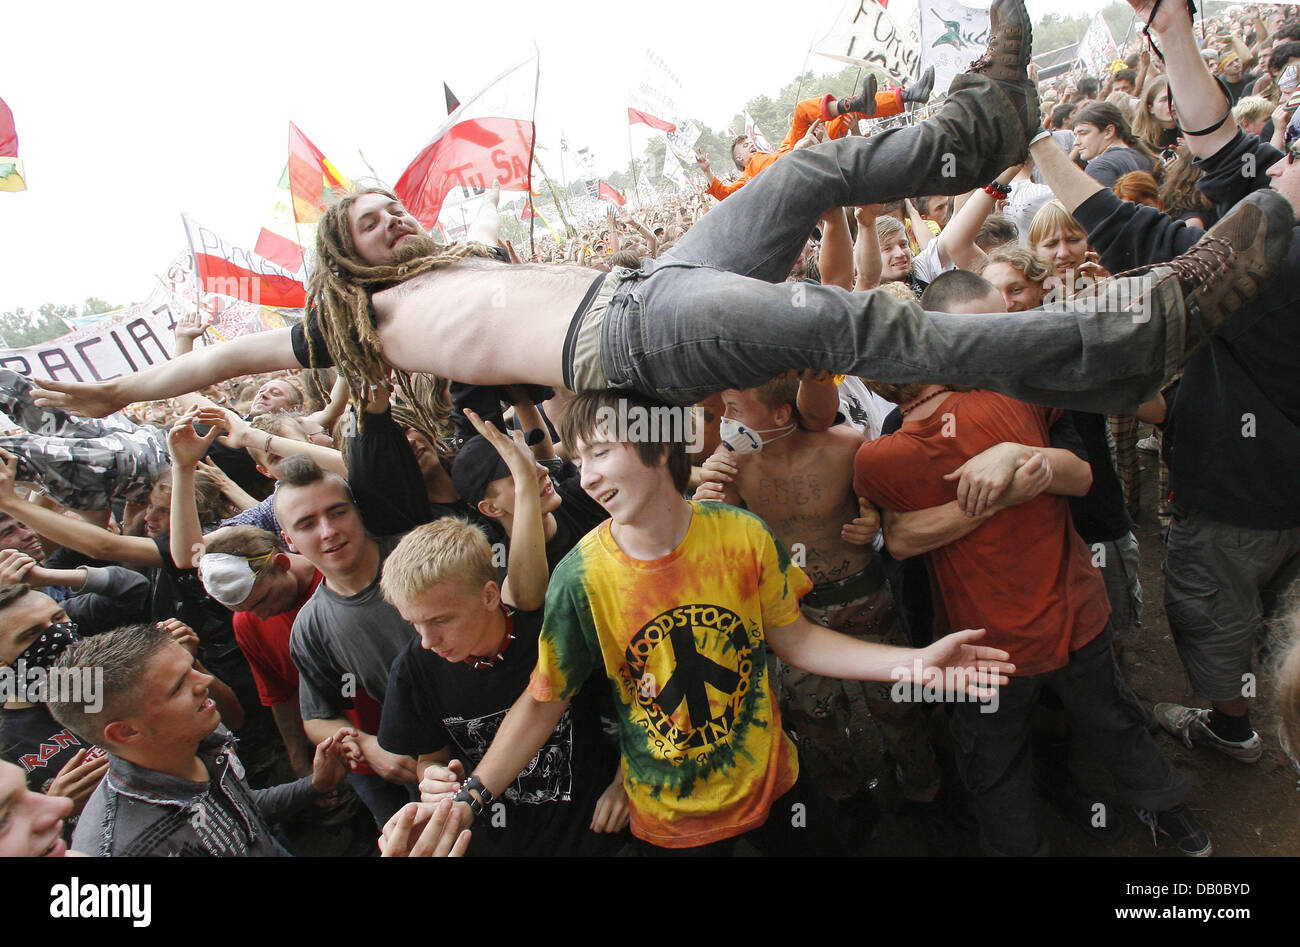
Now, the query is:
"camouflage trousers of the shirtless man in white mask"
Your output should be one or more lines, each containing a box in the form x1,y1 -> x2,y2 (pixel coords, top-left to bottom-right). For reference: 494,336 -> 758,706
772,563 -> 939,799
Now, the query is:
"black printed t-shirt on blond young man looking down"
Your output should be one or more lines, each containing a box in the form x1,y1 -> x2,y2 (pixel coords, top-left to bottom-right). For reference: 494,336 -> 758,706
378,611 -> 623,855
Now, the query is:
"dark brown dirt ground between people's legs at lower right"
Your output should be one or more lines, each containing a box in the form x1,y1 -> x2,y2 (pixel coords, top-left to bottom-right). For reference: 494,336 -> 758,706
855,432 -> 1300,856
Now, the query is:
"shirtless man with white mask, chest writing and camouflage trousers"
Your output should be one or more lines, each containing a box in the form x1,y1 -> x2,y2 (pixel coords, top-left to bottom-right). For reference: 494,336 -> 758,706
696,379 -> 939,801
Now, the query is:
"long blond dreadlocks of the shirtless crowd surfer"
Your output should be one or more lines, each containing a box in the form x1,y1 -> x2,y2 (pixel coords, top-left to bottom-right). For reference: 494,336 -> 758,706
307,187 -> 491,408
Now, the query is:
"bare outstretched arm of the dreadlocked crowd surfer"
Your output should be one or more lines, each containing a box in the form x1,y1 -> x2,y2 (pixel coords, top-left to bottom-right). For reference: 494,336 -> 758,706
33,329 -> 302,418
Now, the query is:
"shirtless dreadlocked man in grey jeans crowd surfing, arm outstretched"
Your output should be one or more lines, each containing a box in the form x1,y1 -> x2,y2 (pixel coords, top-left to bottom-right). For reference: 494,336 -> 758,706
27,0 -> 1294,424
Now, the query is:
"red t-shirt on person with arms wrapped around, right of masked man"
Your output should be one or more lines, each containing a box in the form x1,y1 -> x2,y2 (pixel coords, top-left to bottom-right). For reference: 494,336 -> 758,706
854,392 -> 1110,675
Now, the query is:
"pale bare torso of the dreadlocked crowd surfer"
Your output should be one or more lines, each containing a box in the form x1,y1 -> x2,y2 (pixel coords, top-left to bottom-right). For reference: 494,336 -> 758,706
373,258 -> 601,388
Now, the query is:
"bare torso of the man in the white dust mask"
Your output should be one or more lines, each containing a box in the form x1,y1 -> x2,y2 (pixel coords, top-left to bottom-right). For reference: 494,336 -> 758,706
735,425 -> 871,583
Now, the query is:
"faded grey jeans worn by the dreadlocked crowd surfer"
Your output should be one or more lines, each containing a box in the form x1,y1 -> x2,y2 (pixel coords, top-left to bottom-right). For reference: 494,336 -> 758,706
601,75 -> 1184,414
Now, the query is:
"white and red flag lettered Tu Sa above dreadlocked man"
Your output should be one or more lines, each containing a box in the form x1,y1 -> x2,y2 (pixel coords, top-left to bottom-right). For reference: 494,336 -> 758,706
394,56 -> 538,229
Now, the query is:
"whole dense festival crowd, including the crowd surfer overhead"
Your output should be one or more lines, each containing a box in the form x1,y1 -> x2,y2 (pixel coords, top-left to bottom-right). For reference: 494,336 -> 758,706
0,0 -> 1300,856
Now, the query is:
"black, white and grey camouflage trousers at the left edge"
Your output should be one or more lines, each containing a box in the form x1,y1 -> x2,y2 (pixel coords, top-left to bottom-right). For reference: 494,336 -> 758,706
0,369 -> 170,510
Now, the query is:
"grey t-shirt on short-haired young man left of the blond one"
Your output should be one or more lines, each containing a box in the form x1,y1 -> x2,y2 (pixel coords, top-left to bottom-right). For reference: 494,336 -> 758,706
289,536 -> 416,721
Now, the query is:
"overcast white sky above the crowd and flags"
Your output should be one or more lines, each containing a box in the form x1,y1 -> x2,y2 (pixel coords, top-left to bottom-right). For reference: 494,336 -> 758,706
0,0 -> 1104,311
